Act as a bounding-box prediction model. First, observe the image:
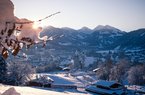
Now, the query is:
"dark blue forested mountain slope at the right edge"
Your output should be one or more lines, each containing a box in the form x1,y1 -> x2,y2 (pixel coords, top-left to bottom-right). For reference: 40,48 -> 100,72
114,29 -> 145,49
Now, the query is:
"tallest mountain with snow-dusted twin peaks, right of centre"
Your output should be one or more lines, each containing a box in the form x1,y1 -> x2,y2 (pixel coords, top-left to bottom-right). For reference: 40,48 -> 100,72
86,25 -> 126,49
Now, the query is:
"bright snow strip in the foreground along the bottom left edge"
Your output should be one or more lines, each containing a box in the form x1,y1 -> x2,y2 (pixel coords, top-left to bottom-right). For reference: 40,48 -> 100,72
0,85 -> 91,95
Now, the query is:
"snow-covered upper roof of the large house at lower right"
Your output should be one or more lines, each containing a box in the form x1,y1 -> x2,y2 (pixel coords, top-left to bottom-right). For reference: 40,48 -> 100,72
93,80 -> 119,87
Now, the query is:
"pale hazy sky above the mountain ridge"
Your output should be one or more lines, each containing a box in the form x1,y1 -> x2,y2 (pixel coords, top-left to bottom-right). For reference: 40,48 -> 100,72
11,0 -> 145,31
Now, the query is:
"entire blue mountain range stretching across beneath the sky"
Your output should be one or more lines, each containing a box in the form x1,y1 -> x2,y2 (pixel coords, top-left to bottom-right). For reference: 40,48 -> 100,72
40,25 -> 145,50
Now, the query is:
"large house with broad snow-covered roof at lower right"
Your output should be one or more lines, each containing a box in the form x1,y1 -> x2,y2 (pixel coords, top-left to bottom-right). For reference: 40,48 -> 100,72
85,80 -> 125,95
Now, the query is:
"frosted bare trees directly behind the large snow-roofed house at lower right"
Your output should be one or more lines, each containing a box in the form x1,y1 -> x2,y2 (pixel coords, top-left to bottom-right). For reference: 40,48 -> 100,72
97,59 -> 131,83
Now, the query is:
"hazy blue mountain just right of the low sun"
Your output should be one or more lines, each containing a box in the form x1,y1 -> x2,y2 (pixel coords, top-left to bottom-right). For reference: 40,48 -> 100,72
41,27 -> 88,49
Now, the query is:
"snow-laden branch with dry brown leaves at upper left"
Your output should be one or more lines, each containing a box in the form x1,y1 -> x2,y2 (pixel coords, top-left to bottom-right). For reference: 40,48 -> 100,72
0,0 -> 47,59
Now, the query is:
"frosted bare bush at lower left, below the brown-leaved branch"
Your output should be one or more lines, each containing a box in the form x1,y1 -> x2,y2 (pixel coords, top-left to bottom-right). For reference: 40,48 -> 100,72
7,63 -> 35,85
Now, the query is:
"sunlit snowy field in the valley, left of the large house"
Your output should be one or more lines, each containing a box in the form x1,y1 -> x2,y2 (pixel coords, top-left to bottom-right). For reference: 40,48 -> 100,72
39,71 -> 95,88
